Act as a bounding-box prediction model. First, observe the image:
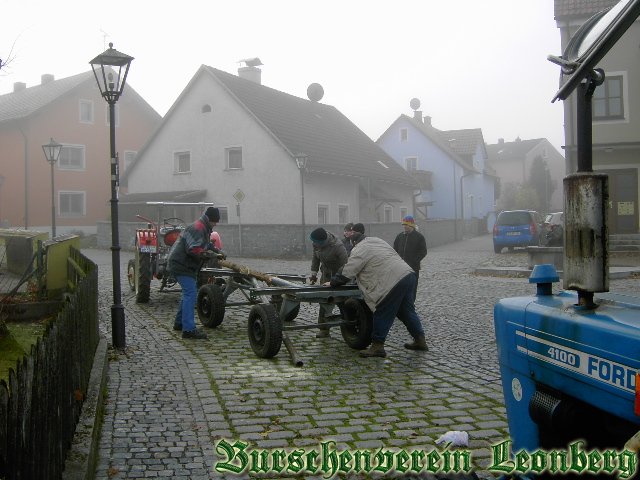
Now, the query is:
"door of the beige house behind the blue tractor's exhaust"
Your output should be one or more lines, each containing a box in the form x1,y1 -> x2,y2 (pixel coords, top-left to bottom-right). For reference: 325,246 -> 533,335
602,168 -> 638,233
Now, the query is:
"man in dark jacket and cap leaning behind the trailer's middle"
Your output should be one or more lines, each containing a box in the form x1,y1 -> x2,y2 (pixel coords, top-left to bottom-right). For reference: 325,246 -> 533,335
309,227 -> 348,338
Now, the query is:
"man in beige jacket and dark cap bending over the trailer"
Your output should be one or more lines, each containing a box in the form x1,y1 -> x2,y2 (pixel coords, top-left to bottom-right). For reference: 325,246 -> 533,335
328,232 -> 428,357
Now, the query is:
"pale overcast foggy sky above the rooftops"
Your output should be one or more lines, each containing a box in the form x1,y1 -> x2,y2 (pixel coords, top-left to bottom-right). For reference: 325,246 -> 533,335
0,0 -> 564,153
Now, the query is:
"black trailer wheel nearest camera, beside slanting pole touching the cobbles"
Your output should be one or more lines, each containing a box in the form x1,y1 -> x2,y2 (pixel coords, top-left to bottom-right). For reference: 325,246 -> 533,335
247,303 -> 282,358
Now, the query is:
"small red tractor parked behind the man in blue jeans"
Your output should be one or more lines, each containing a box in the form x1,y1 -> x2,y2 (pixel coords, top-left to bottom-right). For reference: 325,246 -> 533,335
127,215 -> 186,303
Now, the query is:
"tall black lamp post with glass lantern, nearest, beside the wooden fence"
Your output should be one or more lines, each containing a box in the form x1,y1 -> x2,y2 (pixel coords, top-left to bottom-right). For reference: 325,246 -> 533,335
89,43 -> 133,349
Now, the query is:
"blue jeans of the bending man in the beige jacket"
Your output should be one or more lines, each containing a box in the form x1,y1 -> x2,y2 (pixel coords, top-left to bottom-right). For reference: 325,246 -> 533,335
371,273 -> 424,343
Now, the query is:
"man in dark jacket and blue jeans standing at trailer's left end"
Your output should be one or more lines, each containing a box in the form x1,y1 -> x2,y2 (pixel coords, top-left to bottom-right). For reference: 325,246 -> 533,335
168,207 -> 220,339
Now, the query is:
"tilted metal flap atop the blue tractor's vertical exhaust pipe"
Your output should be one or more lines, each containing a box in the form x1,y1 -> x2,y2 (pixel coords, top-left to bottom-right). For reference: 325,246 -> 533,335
547,0 -> 640,102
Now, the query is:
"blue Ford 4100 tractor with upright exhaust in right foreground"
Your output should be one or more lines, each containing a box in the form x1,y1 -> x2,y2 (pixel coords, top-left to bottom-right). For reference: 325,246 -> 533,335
494,0 -> 640,478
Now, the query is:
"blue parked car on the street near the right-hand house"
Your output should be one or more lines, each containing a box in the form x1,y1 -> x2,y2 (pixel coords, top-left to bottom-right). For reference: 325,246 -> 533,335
493,210 -> 542,253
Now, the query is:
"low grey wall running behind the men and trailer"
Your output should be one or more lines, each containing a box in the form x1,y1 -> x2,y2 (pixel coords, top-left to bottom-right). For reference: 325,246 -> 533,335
97,220 -> 485,258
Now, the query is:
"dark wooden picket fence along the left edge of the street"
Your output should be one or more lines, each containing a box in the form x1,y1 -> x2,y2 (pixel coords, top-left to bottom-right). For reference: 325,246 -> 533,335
0,248 -> 99,480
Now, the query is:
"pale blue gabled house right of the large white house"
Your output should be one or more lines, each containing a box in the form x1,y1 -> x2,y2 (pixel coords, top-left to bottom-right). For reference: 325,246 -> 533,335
377,110 -> 496,225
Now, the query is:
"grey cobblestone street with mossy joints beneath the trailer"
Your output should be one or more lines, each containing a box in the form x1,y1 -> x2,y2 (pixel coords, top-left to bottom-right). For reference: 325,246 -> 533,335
84,235 -> 638,480
